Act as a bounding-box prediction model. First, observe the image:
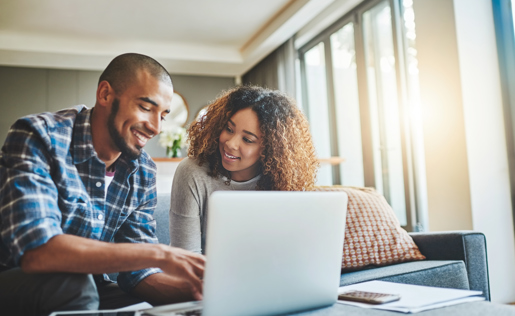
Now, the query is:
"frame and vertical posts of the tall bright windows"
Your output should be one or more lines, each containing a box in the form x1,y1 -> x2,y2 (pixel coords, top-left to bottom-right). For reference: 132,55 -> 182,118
298,0 -> 423,231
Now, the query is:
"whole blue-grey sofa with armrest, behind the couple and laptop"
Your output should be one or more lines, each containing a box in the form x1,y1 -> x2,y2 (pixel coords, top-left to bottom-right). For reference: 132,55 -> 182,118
150,194 -> 490,300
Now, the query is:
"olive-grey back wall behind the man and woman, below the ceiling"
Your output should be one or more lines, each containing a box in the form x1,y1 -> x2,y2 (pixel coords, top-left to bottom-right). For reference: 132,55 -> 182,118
0,67 -> 234,157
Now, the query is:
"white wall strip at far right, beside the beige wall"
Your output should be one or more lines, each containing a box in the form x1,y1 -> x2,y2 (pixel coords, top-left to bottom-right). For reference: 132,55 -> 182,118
454,0 -> 515,302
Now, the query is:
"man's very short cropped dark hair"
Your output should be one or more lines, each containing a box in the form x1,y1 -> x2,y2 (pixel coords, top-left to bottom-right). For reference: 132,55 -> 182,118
98,53 -> 172,94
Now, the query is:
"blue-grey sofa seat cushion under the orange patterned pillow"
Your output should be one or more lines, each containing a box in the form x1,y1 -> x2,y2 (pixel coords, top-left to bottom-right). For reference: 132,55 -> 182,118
340,260 -> 469,290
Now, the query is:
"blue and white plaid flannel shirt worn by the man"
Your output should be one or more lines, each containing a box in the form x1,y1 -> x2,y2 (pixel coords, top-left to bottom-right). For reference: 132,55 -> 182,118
0,105 -> 161,292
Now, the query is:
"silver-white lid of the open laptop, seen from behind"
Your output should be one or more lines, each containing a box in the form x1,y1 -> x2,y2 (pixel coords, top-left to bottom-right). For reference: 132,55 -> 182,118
203,191 -> 347,316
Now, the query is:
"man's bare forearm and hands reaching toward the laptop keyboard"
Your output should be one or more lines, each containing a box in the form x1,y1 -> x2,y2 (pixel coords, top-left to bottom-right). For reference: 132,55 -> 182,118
21,234 -> 205,303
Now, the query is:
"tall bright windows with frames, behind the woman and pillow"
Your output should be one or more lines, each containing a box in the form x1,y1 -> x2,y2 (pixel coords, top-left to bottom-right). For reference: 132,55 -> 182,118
299,0 -> 425,230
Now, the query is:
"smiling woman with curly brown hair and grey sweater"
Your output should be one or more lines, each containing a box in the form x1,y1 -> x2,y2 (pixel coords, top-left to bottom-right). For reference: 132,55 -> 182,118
170,86 -> 318,253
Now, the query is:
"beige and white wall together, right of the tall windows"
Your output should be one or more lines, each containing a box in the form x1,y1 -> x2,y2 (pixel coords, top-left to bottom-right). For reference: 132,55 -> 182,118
413,0 -> 515,303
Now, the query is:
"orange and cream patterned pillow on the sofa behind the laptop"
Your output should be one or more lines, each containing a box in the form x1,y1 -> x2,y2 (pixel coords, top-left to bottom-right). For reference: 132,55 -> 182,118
315,186 -> 426,270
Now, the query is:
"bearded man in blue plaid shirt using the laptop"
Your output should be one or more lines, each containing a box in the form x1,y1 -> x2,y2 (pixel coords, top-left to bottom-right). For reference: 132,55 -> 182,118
0,54 -> 204,315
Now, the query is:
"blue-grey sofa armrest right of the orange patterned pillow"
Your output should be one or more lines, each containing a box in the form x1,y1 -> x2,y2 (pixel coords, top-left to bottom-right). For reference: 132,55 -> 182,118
410,231 -> 490,300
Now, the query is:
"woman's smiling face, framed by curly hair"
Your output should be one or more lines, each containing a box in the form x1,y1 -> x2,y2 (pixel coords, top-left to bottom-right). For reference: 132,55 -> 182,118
219,108 -> 263,182
